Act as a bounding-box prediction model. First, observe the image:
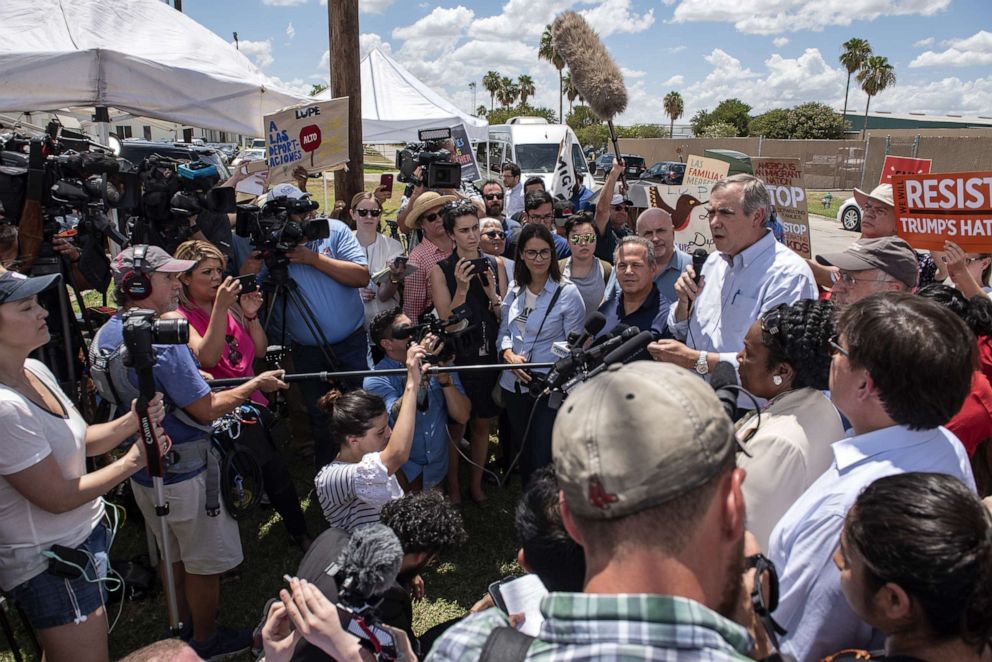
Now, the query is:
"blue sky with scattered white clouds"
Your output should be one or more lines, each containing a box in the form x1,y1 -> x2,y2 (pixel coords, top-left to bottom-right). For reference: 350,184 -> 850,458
183,0 -> 992,124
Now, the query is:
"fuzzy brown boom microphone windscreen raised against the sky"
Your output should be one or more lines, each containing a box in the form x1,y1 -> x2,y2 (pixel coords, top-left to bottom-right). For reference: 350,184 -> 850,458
551,11 -> 627,120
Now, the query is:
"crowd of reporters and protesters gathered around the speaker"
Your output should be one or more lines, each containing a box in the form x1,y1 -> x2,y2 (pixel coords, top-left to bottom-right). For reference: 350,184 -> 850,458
0,153 -> 992,662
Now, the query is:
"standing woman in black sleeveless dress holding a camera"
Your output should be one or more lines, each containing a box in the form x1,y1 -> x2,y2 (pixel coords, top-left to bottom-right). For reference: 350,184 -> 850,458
431,200 -> 507,506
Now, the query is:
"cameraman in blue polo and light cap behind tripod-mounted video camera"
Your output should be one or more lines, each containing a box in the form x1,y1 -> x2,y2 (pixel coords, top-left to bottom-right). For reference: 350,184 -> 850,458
241,184 -> 369,468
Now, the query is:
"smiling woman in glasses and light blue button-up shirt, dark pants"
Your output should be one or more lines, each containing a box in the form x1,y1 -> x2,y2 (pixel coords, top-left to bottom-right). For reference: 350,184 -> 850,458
498,223 -> 586,486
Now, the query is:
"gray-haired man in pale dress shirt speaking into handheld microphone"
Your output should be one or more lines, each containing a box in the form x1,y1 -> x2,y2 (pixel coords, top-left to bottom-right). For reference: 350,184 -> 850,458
648,174 -> 817,375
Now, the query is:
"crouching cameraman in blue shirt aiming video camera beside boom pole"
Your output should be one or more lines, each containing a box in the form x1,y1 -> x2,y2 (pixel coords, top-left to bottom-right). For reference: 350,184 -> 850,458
362,308 -> 472,490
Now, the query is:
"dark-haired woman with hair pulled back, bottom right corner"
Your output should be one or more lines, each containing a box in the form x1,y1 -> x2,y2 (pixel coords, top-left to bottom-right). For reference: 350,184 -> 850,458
826,473 -> 992,662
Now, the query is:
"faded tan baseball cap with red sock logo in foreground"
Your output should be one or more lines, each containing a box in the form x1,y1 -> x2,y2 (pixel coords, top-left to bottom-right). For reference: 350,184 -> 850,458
551,361 -> 737,519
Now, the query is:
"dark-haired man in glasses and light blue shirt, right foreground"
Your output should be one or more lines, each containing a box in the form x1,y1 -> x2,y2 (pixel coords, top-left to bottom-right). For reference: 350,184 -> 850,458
768,292 -> 976,661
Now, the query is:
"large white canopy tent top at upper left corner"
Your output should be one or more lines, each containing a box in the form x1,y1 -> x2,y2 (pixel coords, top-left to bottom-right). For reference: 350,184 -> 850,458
0,0 -> 307,136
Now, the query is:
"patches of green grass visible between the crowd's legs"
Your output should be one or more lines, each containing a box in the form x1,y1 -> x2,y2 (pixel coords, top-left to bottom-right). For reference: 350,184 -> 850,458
0,430 -> 520,661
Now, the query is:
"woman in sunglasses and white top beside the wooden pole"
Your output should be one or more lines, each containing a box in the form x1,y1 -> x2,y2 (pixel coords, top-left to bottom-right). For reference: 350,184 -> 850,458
350,193 -> 406,328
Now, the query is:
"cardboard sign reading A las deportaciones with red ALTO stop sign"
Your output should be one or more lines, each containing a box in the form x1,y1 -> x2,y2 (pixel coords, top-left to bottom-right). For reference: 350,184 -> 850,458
265,97 -> 348,186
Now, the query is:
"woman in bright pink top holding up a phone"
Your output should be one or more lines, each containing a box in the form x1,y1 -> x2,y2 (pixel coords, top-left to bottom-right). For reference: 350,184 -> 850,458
169,240 -> 311,551
